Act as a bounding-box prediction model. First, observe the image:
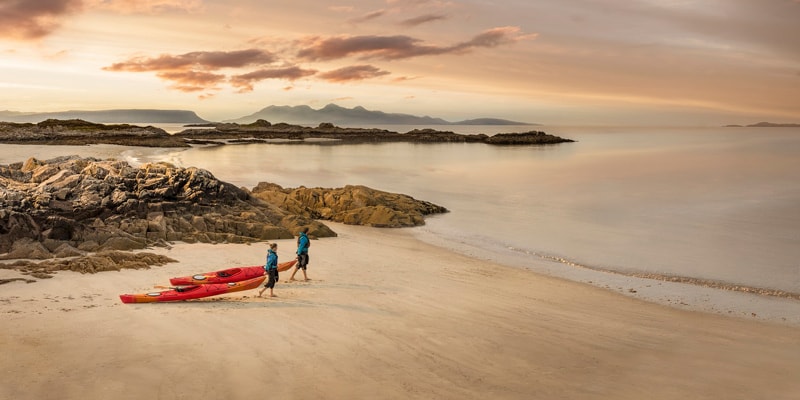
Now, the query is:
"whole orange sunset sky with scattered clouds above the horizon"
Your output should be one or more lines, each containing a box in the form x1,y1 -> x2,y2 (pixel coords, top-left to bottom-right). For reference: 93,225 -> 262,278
0,0 -> 800,126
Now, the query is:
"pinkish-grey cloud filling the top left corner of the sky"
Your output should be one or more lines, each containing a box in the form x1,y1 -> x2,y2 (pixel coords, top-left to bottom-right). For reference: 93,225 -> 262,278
0,0 -> 83,40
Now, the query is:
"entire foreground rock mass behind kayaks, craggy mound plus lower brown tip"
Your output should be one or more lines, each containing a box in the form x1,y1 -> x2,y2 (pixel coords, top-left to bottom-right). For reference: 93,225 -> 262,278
0,156 -> 447,264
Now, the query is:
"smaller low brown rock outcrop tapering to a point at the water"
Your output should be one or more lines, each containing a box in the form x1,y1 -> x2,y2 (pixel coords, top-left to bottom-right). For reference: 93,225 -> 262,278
253,182 -> 447,227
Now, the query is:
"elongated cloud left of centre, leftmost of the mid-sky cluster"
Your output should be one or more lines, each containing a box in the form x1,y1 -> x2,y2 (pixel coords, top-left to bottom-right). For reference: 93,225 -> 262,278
103,49 -> 276,72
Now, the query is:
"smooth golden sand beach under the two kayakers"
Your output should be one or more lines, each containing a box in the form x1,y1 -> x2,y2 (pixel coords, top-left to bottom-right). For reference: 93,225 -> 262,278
0,224 -> 800,400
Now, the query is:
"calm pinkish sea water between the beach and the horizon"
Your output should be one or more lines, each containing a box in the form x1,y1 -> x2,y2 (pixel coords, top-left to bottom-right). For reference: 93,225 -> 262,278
0,126 -> 800,320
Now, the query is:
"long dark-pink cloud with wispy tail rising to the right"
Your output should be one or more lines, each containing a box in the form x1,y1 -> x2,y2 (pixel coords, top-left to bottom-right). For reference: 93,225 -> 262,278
297,26 -> 535,61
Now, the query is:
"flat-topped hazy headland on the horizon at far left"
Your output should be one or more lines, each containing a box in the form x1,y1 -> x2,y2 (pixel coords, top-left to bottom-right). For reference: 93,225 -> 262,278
0,109 -> 209,124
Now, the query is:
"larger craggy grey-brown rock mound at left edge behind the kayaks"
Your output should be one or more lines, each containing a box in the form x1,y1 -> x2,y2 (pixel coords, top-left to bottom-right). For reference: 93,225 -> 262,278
0,156 -> 336,259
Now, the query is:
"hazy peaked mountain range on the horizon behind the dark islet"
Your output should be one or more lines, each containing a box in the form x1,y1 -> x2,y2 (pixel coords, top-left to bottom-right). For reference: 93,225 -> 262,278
224,104 -> 536,126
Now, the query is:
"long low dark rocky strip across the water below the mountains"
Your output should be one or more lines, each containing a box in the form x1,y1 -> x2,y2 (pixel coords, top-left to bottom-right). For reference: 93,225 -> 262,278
0,119 -> 573,147
